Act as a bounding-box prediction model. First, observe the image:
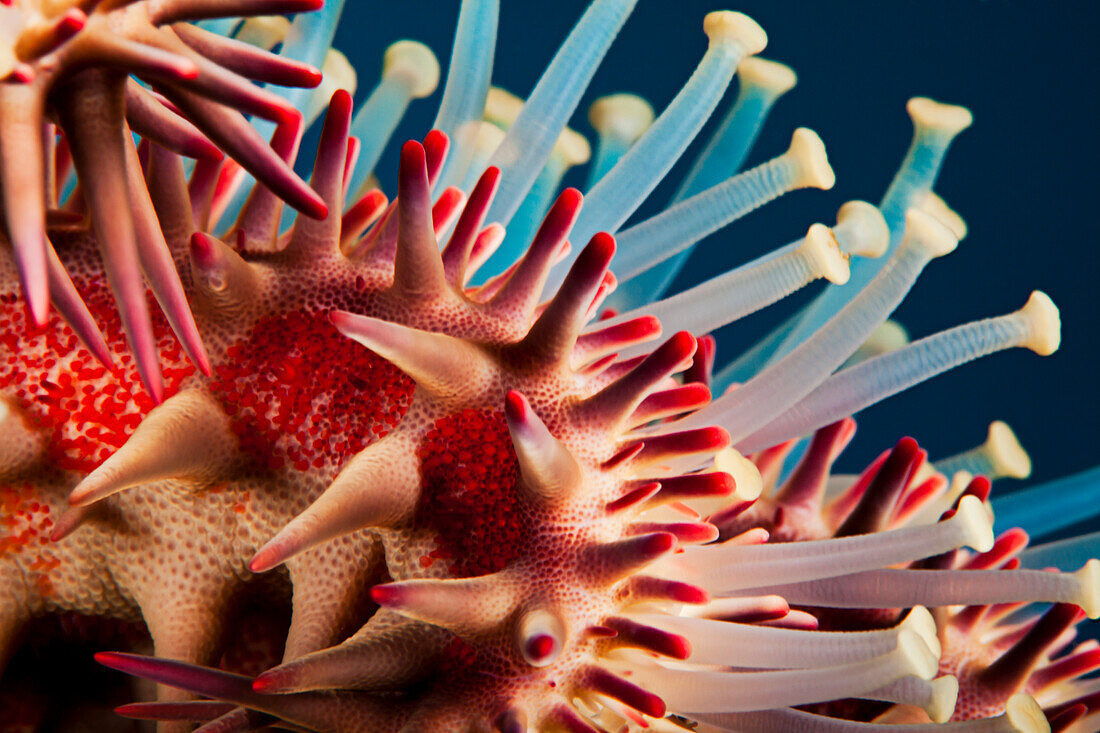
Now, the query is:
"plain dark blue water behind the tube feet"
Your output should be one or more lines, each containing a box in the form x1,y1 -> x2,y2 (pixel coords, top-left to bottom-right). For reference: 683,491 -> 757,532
336,0 -> 1100,489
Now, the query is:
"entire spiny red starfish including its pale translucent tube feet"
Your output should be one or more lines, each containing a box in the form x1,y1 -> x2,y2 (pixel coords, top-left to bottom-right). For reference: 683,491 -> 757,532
0,0 -> 1100,733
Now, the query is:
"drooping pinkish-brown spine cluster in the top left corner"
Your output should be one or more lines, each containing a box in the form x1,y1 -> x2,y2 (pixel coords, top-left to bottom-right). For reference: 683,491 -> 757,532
0,0 -> 326,401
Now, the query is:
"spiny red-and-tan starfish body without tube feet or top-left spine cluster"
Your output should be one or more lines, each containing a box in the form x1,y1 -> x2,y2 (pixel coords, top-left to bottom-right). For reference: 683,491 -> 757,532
0,0 -> 1100,733
